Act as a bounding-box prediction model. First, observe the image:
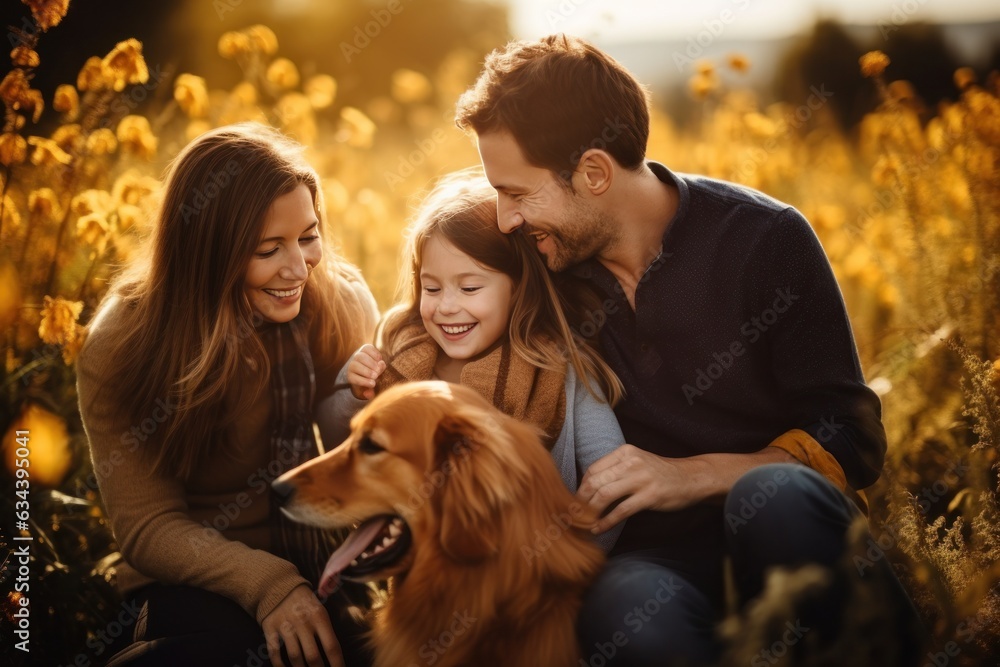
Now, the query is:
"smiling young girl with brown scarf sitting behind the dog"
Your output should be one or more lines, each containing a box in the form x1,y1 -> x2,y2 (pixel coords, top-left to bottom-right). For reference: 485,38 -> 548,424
320,172 -> 624,550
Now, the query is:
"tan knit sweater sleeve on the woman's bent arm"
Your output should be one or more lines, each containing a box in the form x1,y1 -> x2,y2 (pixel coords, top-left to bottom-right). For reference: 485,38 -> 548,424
77,314 -> 308,623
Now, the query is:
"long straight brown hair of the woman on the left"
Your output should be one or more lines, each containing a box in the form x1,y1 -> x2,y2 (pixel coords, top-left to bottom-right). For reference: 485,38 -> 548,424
94,123 -> 372,477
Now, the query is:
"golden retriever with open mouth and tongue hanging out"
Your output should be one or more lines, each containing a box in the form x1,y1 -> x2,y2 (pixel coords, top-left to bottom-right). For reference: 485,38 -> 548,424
274,382 -> 604,667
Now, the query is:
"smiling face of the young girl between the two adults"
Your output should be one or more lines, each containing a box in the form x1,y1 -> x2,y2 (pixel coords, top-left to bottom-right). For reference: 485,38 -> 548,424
419,235 -> 514,361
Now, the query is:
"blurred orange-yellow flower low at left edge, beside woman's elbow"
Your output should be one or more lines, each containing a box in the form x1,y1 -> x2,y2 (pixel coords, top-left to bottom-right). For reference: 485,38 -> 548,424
3,403 -> 73,488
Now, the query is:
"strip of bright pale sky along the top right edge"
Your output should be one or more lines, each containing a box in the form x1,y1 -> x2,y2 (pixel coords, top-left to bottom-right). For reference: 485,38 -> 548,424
507,0 -> 1000,43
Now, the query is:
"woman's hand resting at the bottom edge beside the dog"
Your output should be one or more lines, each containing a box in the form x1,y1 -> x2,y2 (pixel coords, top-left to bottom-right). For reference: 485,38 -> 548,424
260,584 -> 344,667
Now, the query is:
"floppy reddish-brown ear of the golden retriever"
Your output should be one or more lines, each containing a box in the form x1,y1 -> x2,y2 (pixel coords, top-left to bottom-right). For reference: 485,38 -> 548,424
434,414 -> 512,563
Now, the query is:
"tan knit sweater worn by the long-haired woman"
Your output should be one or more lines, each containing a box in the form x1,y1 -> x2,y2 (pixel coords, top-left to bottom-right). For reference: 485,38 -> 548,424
77,276 -> 378,623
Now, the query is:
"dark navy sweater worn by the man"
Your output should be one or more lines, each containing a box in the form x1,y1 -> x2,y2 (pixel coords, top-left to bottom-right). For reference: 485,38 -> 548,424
564,162 -> 886,576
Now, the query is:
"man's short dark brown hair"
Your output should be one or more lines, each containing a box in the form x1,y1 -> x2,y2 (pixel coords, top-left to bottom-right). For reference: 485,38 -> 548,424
455,34 -> 649,181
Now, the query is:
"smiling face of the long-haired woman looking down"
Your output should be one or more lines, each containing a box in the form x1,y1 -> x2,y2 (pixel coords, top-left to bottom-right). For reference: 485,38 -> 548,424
243,185 -> 323,322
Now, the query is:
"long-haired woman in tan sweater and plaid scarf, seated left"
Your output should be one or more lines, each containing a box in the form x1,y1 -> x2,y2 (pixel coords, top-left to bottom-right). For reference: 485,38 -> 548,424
78,124 -> 378,666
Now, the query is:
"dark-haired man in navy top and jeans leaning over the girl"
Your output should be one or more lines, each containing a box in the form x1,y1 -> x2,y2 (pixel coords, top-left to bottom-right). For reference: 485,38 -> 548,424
456,35 -> 912,667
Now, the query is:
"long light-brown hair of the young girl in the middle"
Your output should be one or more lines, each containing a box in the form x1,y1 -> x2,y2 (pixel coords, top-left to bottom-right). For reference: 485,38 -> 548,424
378,169 -> 623,405
